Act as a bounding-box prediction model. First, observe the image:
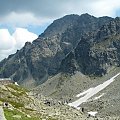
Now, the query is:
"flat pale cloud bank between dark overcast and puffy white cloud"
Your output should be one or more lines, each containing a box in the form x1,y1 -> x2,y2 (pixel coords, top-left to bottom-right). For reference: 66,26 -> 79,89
0,12 -> 51,27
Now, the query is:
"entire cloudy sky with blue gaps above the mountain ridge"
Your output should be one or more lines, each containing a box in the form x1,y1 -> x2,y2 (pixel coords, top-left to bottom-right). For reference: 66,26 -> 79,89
0,0 -> 120,60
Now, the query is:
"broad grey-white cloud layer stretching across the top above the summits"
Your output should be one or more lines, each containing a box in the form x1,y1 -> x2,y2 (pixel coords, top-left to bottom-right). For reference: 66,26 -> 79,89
0,0 -> 120,27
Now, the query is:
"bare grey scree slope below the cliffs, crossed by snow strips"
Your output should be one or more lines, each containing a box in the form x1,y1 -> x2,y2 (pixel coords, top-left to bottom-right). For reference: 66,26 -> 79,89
34,67 -> 120,120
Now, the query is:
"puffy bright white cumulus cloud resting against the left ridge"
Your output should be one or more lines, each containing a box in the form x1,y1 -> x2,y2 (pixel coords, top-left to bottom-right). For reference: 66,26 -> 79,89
0,28 -> 38,60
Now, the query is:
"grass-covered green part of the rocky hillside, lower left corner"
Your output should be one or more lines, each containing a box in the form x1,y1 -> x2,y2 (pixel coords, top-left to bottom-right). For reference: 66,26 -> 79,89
0,84 -> 55,120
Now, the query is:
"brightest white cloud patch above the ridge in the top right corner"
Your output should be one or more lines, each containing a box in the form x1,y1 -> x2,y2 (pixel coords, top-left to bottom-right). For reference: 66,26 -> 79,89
89,0 -> 120,17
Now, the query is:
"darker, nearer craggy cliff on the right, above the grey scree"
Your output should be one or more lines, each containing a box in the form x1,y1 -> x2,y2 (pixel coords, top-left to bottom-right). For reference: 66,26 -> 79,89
61,18 -> 120,76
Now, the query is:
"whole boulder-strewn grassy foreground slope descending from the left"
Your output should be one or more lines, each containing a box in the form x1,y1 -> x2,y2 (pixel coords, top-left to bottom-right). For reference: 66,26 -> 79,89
0,84 -> 93,120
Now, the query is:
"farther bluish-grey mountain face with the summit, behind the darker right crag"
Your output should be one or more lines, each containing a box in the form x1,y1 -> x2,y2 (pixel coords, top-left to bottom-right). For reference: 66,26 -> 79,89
0,14 -> 113,87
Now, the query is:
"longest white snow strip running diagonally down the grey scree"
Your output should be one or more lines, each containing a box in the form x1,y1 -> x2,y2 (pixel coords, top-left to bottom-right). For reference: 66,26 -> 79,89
68,73 -> 120,109
